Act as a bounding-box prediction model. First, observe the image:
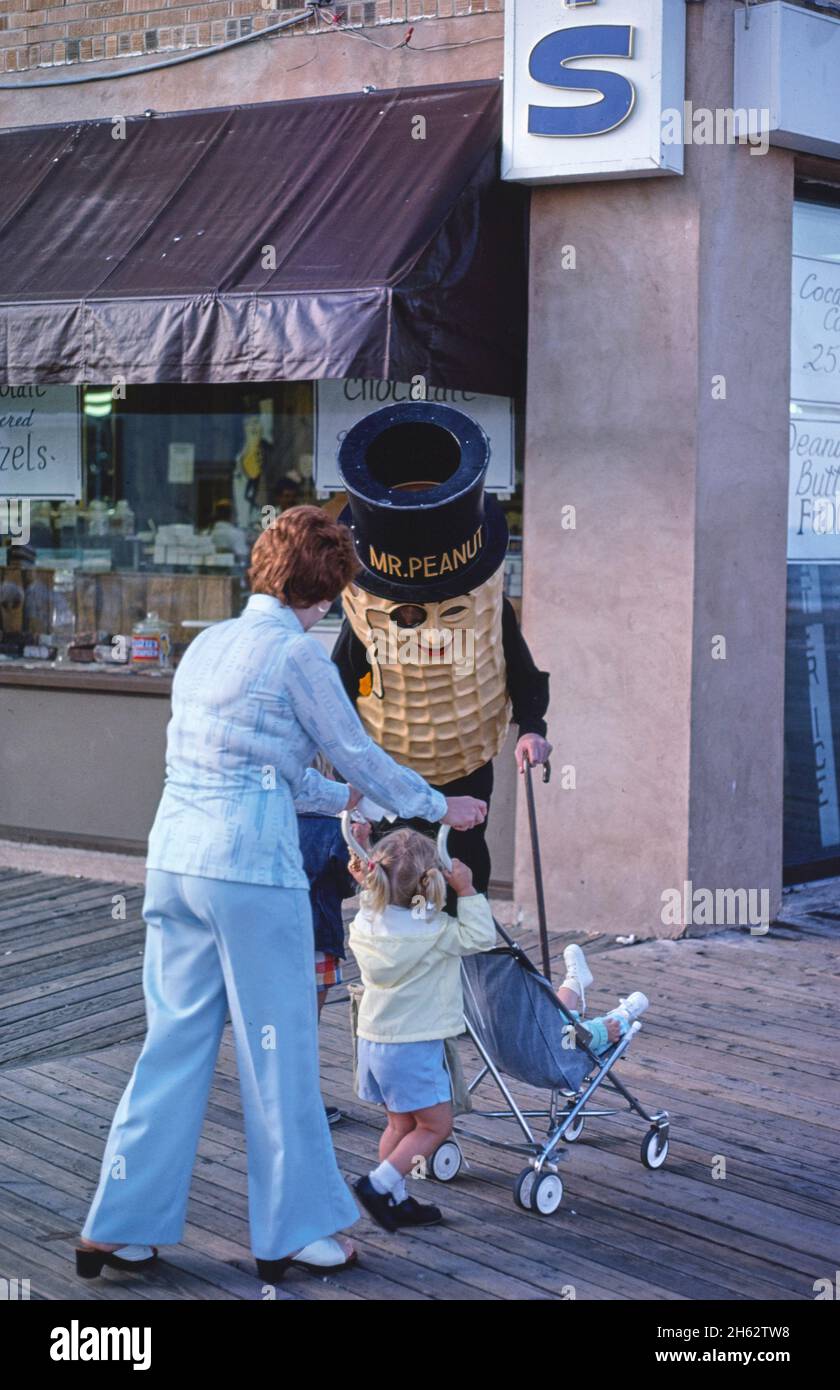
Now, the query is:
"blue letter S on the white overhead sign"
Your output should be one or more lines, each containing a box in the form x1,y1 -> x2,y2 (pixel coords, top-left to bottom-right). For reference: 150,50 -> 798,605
528,24 -> 636,135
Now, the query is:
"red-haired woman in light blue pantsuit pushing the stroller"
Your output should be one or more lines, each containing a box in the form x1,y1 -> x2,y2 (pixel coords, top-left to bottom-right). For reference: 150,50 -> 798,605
76,507 -> 485,1279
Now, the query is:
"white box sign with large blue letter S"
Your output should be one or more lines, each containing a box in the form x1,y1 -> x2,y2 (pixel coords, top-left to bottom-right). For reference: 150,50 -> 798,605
502,0 -> 686,183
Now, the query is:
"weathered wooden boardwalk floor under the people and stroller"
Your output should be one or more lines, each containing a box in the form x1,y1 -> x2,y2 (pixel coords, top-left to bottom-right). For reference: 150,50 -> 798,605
0,870 -> 840,1302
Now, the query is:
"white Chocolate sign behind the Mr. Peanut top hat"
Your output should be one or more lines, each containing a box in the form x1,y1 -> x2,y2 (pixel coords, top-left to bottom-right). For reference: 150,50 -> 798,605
313,377 -> 516,495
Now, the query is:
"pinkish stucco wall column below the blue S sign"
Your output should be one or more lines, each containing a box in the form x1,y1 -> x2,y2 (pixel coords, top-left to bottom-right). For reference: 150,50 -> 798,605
516,0 -> 793,935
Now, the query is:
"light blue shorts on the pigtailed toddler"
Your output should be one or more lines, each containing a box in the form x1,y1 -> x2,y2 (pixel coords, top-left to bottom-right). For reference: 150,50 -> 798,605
357,1038 -> 452,1115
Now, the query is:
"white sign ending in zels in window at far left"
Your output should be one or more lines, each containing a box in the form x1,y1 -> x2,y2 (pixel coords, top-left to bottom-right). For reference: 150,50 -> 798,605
0,386 -> 82,502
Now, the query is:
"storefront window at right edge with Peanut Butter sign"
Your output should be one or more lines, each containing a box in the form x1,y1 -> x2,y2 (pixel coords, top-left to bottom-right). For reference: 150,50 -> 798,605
784,200 -> 840,880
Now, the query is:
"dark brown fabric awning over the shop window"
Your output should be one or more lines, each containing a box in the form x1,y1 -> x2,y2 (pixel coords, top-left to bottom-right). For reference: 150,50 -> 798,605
0,82 -> 527,395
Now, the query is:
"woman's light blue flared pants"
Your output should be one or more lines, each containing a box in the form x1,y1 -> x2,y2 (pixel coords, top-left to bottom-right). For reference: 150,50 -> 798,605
83,869 -> 359,1259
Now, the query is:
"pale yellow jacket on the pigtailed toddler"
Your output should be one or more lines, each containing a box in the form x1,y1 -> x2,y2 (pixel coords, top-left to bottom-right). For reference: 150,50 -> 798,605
349,892 -> 496,1043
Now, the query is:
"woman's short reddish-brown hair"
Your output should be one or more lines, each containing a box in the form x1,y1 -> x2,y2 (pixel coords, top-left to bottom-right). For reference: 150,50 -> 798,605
248,506 -> 360,607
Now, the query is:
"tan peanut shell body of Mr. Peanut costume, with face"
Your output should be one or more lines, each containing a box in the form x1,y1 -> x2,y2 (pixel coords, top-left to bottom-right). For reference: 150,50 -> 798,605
342,569 -> 510,787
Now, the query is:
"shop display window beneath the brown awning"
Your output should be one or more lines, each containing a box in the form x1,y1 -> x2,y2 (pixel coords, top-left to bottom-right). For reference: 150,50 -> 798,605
0,381 -> 522,667
